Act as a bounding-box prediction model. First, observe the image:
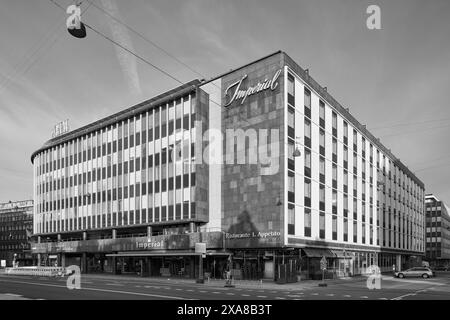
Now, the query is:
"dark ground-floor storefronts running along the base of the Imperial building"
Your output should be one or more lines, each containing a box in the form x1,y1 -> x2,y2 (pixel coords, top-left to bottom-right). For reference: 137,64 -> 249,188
33,232 -> 422,283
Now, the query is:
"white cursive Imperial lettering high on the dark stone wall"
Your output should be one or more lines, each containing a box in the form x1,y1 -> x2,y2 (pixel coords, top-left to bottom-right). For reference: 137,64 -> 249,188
224,69 -> 281,107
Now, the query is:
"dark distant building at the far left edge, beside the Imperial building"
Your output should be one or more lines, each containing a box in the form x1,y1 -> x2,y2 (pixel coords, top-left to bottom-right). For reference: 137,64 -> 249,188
0,200 -> 33,267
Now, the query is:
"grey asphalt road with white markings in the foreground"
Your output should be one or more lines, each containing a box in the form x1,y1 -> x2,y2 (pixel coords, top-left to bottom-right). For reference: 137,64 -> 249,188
0,274 -> 450,301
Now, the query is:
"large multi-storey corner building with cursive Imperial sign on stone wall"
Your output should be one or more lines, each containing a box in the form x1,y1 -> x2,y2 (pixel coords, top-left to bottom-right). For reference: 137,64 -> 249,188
31,52 -> 425,279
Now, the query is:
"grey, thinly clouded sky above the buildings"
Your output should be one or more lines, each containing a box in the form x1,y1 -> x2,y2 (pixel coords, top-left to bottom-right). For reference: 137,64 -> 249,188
0,0 -> 450,204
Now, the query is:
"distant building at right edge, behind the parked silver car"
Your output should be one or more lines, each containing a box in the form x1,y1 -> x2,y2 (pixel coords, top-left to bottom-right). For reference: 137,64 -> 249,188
425,194 -> 450,266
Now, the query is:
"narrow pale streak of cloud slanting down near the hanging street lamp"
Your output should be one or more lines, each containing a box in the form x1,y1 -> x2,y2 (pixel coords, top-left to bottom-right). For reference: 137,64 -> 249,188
101,0 -> 142,95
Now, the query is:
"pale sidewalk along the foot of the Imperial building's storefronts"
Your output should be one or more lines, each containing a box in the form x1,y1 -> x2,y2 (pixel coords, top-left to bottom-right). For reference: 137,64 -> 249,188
82,274 -> 384,290
